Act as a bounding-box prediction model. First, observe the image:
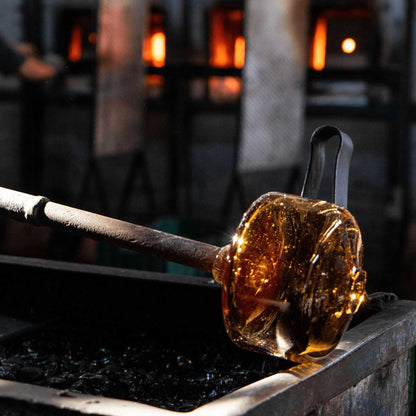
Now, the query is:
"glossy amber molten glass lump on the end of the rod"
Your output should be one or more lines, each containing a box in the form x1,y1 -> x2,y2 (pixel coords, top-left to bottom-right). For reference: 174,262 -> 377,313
213,193 -> 366,362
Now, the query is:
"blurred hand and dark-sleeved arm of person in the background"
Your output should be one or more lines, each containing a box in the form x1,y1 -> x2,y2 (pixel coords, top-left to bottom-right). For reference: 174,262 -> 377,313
0,37 -> 56,82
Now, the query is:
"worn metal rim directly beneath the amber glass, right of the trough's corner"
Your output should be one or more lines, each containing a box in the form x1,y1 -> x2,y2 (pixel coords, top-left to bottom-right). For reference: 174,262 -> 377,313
192,300 -> 416,416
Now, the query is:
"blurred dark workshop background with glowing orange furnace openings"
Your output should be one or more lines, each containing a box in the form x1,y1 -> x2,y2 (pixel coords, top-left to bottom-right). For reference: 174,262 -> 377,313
0,0 -> 416,298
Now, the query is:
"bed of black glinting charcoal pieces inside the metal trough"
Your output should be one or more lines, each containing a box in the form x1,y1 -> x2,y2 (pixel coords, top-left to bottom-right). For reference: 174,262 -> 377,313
0,324 -> 290,411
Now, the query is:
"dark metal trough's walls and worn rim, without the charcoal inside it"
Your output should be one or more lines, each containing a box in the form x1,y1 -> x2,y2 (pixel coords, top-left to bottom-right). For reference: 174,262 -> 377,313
0,256 -> 416,416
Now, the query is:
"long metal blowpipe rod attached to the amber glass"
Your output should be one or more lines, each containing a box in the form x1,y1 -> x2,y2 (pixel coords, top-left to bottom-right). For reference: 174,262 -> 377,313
0,187 -> 221,273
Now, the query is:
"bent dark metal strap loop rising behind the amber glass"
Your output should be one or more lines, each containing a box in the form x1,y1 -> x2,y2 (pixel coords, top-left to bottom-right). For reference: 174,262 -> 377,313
301,126 -> 354,208
